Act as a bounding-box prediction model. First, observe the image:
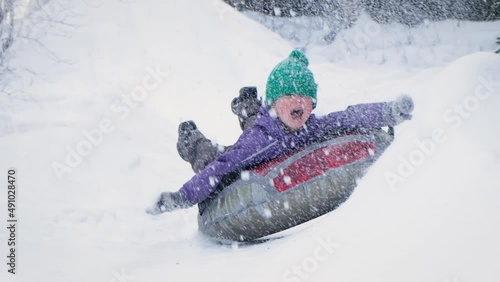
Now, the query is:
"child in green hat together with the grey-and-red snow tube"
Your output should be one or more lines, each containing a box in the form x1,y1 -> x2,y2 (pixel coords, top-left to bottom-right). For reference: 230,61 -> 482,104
149,50 -> 413,241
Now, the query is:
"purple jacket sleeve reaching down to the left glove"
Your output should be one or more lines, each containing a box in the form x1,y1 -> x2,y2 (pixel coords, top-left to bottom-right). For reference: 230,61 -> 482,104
180,124 -> 279,204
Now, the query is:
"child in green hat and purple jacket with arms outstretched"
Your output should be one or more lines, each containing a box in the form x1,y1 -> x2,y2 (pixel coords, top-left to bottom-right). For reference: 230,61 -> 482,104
152,50 -> 413,213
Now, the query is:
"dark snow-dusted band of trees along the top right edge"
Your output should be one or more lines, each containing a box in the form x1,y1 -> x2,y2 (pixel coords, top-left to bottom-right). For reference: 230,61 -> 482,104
224,0 -> 490,23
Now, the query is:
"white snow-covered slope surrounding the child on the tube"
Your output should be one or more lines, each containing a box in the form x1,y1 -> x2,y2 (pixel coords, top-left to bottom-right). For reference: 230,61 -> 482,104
0,0 -> 500,282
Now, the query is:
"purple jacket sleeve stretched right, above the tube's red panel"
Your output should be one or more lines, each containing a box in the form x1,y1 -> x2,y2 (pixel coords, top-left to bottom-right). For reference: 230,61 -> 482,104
319,103 -> 394,130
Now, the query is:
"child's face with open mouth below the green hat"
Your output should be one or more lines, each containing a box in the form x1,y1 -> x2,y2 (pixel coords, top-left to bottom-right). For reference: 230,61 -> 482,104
273,95 -> 313,131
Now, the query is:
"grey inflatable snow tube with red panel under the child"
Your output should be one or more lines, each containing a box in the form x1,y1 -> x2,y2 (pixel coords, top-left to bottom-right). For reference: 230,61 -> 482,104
198,128 -> 393,242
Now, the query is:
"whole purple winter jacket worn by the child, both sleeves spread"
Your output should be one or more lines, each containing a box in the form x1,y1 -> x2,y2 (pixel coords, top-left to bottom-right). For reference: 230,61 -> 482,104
180,103 -> 395,204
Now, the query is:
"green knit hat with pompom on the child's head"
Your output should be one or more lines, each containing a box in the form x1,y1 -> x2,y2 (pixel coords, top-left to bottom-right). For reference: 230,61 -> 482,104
265,50 -> 318,108
